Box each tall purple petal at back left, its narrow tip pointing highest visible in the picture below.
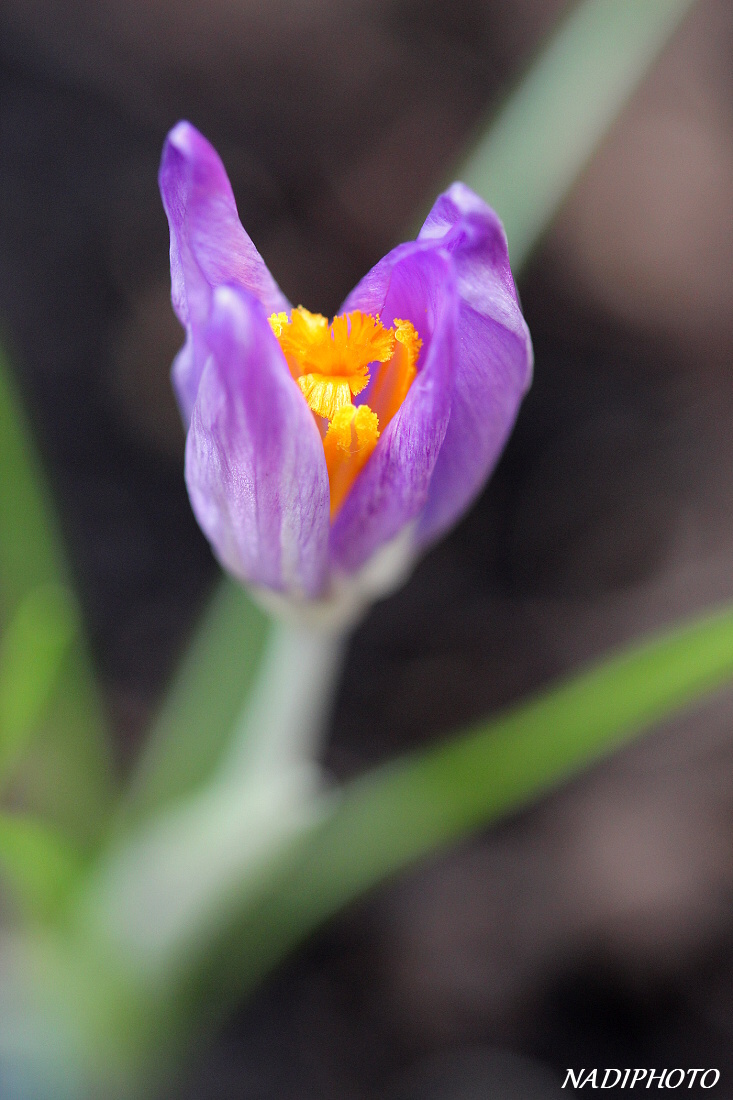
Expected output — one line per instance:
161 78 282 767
158 122 291 422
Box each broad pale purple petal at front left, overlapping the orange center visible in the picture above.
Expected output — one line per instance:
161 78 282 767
186 287 329 596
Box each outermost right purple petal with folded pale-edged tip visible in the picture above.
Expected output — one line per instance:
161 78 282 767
417 184 533 543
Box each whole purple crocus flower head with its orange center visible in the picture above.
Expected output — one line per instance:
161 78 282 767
160 122 532 620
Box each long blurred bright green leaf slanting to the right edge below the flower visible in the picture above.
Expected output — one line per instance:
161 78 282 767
197 607 733 997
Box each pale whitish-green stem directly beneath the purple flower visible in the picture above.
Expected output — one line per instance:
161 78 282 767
80 624 344 986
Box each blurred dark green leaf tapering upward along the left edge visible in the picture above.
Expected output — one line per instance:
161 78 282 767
0 338 111 842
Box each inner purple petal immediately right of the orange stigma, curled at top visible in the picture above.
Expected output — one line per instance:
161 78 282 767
330 245 457 572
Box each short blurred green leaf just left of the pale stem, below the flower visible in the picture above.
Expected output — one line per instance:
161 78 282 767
121 580 269 824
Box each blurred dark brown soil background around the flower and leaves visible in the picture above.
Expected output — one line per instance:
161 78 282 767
0 0 733 1100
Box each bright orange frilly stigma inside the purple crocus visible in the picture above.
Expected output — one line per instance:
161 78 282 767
270 306 423 519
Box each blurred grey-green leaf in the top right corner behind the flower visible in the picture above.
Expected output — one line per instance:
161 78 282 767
457 0 693 272
